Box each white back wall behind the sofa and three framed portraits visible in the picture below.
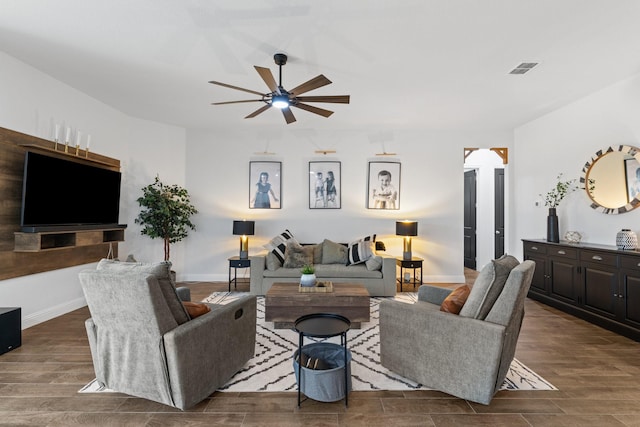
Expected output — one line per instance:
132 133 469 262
185 129 511 282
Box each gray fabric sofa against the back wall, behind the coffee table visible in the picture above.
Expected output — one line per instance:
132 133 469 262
249 240 396 296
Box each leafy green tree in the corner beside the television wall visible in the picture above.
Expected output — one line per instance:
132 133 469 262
135 176 198 261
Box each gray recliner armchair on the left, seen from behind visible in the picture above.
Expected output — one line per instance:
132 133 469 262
80 261 256 409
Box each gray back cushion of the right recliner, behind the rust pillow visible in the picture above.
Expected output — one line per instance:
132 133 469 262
460 254 520 320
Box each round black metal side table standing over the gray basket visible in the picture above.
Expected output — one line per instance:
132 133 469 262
294 313 351 408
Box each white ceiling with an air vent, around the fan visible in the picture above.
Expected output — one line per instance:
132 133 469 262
0 0 640 130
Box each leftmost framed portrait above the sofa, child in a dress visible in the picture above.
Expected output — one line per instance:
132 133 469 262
249 162 282 209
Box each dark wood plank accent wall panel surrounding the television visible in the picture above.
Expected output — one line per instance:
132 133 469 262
0 128 120 280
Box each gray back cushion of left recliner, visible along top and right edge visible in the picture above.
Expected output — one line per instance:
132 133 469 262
96 259 189 325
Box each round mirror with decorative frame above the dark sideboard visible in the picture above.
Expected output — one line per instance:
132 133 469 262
580 145 640 214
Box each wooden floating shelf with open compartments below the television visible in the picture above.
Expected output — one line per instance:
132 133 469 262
14 228 124 252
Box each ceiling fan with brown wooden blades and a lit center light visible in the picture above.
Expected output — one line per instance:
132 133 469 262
209 53 349 124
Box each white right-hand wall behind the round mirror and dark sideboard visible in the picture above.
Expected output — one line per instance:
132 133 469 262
510 75 640 256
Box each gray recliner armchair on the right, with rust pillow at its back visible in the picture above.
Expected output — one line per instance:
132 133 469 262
380 256 535 405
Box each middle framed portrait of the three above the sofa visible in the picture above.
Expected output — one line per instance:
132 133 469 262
309 162 342 209
